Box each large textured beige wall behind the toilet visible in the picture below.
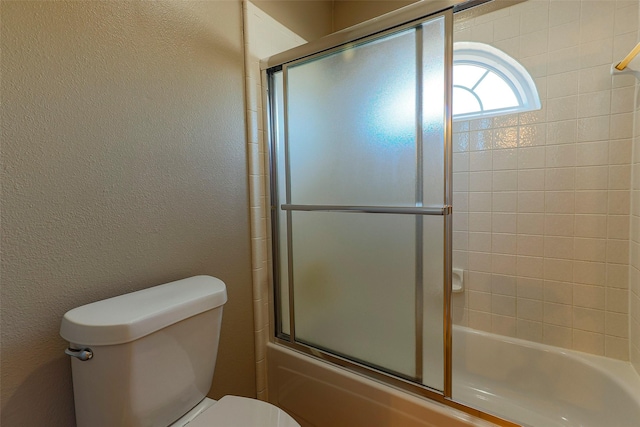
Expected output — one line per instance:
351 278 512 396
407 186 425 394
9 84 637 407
1 1 255 427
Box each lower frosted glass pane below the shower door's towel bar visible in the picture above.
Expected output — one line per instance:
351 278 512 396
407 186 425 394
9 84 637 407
292 212 416 377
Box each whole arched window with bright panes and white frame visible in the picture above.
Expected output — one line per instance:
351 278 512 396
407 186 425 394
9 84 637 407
453 42 540 120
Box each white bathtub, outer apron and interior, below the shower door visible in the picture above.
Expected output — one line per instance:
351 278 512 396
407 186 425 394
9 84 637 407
267 326 640 427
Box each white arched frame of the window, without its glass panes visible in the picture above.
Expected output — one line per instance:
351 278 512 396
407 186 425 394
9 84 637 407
453 42 541 120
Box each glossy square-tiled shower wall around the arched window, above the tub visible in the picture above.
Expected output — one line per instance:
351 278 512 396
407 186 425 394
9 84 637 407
453 0 640 362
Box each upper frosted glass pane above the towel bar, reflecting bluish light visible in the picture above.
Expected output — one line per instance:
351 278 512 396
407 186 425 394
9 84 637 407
287 29 416 206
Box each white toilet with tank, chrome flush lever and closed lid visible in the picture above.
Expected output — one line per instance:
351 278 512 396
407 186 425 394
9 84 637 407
60 276 300 427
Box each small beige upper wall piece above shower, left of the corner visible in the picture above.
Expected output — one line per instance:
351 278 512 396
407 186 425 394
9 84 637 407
252 0 333 41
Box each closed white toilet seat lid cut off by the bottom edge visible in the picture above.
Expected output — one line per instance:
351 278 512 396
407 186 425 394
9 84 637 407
188 396 300 427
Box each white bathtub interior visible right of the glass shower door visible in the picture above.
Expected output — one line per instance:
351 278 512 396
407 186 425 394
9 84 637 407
453 326 640 427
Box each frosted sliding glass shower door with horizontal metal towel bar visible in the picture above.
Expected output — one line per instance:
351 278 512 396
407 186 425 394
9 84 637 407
268 12 451 391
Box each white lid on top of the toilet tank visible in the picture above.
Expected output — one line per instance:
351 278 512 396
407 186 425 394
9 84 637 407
60 276 227 346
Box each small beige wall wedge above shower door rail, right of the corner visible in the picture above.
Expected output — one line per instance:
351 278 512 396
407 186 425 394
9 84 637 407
333 0 416 31
